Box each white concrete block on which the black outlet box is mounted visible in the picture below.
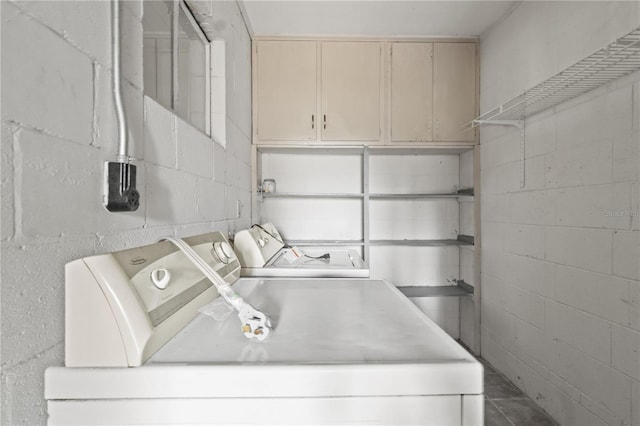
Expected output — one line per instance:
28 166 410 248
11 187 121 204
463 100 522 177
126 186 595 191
16 130 145 237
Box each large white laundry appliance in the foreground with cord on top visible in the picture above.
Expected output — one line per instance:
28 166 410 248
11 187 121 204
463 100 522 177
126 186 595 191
45 233 484 425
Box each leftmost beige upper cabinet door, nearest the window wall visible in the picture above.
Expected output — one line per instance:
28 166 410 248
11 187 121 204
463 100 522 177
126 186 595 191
255 41 318 141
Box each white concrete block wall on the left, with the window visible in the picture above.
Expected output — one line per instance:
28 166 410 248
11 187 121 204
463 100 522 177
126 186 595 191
0 1 251 425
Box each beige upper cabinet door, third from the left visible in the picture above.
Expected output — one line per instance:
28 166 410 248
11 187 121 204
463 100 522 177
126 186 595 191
390 43 433 142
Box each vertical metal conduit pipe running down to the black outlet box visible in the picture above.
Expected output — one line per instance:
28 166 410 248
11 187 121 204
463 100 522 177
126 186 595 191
111 0 129 163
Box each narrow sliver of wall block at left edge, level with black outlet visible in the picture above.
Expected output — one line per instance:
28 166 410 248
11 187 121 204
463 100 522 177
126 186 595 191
0 125 18 241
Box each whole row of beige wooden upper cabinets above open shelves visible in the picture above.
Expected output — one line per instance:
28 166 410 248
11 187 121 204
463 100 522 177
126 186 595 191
253 40 478 144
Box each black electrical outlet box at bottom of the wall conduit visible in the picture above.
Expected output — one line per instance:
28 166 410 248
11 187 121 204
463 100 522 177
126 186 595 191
103 161 140 212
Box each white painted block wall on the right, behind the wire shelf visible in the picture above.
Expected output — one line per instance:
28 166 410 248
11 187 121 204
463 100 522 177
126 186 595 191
480 2 640 425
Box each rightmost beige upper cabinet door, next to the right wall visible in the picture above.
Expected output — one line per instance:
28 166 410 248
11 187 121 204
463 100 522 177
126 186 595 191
433 43 476 141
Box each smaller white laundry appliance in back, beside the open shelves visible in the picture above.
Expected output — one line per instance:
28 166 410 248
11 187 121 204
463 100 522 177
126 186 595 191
234 223 369 278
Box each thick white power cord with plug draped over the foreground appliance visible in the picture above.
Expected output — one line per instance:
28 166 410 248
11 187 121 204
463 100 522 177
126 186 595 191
161 237 271 341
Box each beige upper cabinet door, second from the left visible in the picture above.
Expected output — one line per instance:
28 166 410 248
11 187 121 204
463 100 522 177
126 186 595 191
321 42 382 141
